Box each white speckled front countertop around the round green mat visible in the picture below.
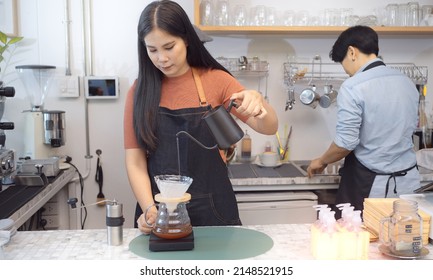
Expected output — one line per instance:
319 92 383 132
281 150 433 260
0 224 433 260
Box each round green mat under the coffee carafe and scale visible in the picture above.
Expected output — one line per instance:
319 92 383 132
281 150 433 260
129 227 274 260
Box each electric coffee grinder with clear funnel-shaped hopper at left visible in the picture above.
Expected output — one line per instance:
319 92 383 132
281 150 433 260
15 65 66 159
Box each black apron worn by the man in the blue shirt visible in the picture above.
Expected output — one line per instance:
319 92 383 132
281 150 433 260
336 61 417 213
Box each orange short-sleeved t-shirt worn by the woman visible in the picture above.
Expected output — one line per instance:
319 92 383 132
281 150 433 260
123 69 246 149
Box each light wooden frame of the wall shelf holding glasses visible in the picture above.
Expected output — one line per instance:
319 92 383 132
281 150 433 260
194 0 433 37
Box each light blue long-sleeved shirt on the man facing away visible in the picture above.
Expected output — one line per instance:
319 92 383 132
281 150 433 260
334 59 419 173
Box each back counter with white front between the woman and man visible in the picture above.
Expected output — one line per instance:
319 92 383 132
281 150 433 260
228 161 339 225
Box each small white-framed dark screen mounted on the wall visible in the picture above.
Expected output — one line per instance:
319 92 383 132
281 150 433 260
84 76 119 99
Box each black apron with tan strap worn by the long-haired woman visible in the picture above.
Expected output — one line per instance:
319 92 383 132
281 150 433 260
135 68 241 227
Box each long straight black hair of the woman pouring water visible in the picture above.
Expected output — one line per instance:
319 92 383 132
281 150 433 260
133 0 230 152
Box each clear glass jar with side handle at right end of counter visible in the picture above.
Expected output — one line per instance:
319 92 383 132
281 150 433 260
380 199 423 257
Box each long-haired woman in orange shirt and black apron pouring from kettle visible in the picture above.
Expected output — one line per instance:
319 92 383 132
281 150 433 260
124 0 278 233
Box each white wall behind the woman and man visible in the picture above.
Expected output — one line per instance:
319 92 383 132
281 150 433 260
2 0 433 228
